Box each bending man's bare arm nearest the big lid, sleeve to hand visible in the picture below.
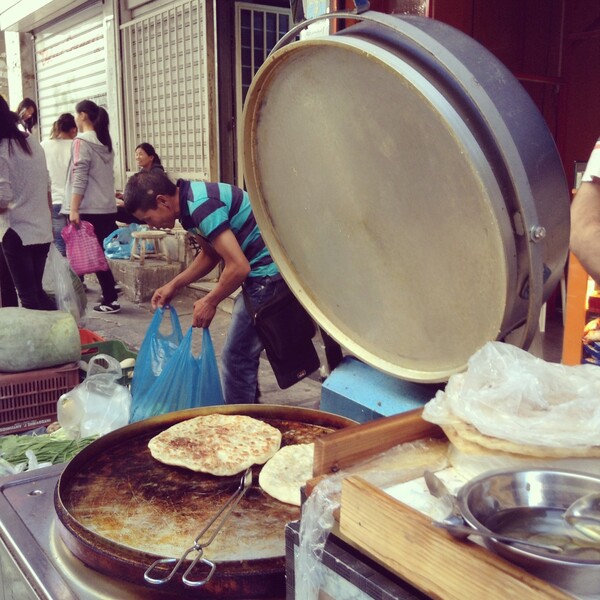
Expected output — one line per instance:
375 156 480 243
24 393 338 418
192 229 250 328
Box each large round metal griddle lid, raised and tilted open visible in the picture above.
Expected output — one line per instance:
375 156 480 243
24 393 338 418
244 12 569 382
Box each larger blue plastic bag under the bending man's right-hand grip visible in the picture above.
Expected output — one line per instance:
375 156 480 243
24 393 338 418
130 327 224 423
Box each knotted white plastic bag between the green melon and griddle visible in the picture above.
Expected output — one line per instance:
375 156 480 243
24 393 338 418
57 354 131 439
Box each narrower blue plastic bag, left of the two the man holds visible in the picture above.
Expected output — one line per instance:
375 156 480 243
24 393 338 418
131 305 183 398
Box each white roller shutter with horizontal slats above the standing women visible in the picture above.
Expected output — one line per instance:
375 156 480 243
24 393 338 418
34 2 107 139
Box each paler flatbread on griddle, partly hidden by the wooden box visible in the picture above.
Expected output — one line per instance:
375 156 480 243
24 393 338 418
258 444 315 506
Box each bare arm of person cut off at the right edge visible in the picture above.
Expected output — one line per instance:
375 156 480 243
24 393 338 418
570 179 600 283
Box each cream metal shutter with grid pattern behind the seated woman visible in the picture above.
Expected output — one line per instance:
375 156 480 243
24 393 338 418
121 0 216 179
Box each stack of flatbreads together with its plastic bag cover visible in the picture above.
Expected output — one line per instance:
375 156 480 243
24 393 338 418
423 342 600 476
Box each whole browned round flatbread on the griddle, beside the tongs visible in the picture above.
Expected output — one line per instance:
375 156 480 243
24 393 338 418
148 414 281 476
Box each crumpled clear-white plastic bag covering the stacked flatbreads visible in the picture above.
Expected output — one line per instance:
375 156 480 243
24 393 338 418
423 342 600 448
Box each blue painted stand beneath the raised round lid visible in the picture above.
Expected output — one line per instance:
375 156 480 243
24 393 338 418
320 356 446 423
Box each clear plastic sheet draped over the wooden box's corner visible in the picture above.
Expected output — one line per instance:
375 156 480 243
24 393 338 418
296 440 447 600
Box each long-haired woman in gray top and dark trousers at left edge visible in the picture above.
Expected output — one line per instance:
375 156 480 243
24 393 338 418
0 96 56 310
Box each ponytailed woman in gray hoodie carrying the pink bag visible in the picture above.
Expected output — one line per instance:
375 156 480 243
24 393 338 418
61 100 121 313
